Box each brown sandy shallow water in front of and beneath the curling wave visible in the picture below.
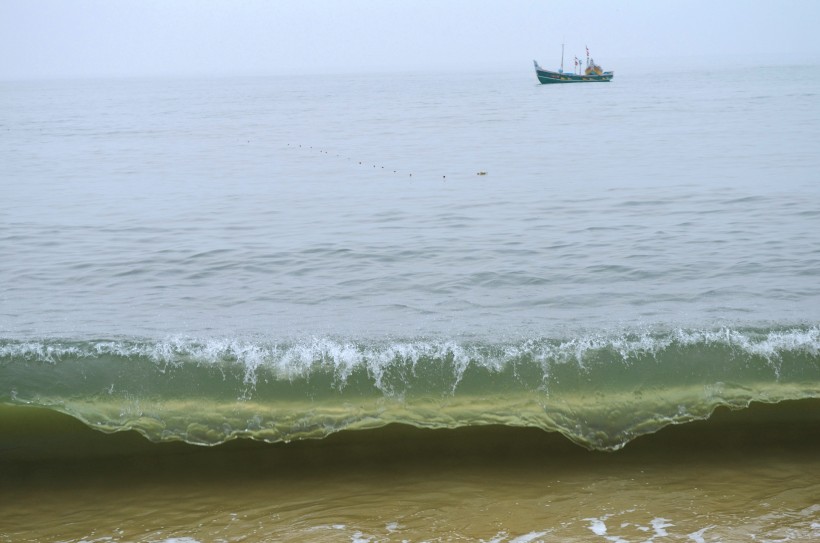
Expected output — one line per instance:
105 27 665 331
0 401 820 543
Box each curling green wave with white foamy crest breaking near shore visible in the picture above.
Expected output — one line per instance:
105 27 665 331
0 326 820 450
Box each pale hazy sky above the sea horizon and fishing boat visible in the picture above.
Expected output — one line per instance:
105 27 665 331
0 0 820 79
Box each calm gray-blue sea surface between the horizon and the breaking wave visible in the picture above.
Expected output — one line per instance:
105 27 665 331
0 68 820 338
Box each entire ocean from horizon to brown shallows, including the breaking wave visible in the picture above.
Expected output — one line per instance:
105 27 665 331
0 68 820 543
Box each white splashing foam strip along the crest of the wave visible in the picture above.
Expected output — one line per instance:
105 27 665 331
0 326 820 377
